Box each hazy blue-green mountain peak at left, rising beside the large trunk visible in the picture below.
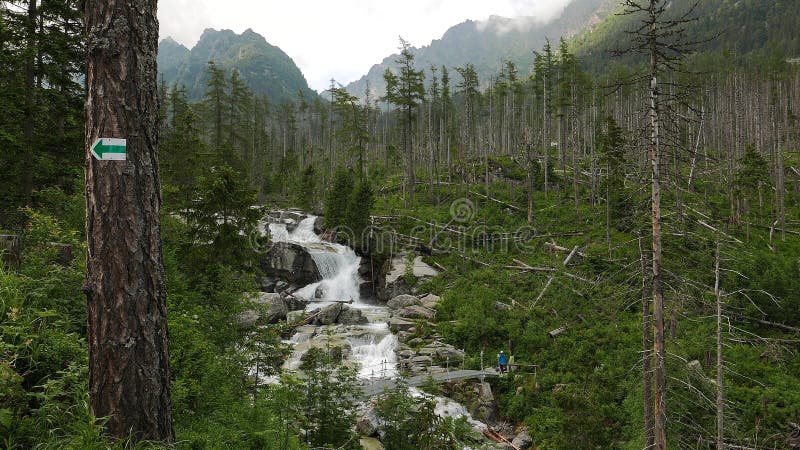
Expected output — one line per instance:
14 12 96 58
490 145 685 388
158 28 317 102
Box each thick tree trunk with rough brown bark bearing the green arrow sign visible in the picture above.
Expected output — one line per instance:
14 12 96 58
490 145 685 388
84 0 174 442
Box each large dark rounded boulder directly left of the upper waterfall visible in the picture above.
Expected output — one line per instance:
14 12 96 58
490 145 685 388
261 242 322 285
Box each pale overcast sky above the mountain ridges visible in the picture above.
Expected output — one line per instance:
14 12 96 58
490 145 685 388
158 0 579 91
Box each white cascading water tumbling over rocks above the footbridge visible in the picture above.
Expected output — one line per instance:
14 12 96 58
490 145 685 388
269 216 397 379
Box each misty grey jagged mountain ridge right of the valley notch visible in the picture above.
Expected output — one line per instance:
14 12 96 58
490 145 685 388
346 0 617 98
